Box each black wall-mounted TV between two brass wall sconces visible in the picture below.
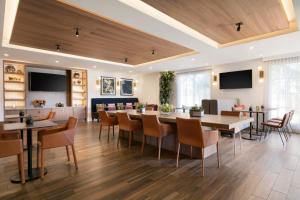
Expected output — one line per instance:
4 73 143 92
219 70 252 89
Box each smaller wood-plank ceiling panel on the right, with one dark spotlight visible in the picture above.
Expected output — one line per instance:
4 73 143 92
142 0 289 44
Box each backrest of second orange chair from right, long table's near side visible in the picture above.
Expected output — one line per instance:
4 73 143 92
142 114 160 137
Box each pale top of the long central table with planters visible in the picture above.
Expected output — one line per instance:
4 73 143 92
108 110 254 129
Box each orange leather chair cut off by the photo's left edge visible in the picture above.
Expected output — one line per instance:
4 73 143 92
0 130 25 184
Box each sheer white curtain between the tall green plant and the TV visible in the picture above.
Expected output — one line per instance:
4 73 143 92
176 71 211 107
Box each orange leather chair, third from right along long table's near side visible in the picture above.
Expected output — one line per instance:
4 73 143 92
117 112 142 149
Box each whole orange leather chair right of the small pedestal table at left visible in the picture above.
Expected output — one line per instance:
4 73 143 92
38 117 78 177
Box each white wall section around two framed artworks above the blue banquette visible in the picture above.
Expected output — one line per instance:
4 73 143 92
88 69 141 119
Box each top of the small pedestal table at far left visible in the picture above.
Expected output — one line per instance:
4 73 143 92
3 120 58 131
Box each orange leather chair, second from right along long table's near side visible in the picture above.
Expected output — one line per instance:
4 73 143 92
142 115 176 160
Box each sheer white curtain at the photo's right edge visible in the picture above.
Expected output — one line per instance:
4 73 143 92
265 57 300 132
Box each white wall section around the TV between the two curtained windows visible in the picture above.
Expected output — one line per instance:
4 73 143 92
211 60 267 107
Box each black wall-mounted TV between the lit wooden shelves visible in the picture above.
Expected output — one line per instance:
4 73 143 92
28 72 67 92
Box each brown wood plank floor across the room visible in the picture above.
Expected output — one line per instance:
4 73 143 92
0 123 300 200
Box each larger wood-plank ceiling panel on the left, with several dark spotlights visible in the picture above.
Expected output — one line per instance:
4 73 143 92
10 0 192 65
